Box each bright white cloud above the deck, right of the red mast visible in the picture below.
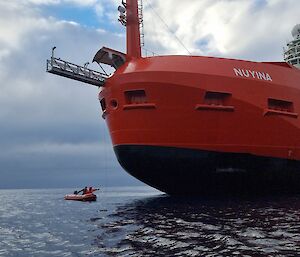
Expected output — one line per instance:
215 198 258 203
144 0 300 61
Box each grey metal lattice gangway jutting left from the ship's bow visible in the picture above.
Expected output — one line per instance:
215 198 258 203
47 48 109 87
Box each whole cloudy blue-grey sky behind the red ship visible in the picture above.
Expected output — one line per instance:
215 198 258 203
0 0 300 189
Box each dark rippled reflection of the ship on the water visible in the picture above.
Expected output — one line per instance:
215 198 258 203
93 196 300 256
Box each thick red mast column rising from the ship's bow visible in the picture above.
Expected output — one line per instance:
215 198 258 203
126 0 142 59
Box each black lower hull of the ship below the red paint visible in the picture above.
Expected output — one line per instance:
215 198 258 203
114 145 300 195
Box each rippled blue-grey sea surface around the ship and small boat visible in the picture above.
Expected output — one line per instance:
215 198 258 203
0 187 300 257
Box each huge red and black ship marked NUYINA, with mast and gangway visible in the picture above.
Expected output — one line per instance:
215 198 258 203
48 0 300 195
